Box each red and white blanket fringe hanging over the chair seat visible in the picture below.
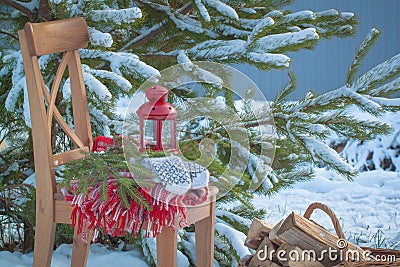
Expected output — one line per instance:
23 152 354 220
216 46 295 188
61 179 208 242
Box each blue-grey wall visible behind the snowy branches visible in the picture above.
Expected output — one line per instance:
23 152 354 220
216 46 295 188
234 0 400 100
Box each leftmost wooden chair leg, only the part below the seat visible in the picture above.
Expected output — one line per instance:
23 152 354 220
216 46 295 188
33 219 56 267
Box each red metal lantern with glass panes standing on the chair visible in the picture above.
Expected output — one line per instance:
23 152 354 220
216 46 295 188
136 85 178 152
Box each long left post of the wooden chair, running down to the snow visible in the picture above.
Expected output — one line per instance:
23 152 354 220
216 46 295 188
18 31 56 267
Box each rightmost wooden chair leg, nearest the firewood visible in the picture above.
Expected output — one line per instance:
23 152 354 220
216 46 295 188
195 200 215 267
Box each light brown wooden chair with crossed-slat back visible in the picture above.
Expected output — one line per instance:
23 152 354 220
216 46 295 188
18 18 218 267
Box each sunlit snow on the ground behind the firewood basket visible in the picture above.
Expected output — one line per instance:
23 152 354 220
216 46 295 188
254 169 400 249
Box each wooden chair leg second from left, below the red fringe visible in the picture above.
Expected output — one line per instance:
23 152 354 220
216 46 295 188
71 225 93 267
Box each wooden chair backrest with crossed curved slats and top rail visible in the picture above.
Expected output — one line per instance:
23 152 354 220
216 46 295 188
18 18 92 197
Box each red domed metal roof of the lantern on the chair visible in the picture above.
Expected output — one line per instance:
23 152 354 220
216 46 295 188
136 85 178 120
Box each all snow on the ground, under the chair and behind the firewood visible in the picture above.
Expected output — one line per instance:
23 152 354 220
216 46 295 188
0 169 400 267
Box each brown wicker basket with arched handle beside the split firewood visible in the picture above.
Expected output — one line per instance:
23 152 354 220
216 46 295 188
304 202 400 267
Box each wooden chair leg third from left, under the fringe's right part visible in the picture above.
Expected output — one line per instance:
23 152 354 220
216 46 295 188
156 227 178 267
